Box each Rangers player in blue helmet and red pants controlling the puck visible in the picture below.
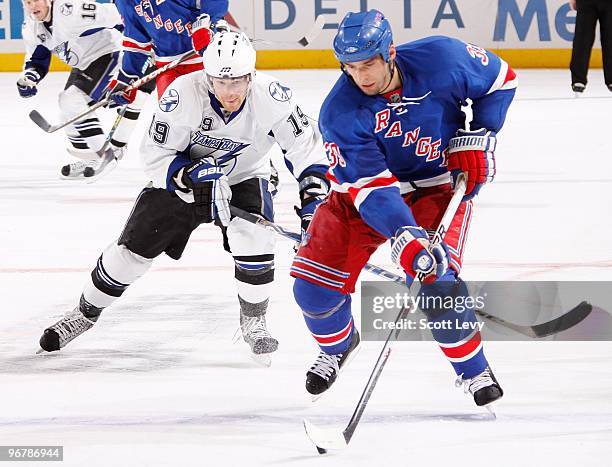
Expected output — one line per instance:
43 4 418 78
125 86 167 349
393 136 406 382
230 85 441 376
291 10 517 406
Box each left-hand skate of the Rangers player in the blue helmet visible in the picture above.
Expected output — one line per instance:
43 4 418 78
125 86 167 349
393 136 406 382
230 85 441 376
306 329 361 402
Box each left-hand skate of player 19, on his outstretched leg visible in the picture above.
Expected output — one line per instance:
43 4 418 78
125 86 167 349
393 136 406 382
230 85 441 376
37 297 102 353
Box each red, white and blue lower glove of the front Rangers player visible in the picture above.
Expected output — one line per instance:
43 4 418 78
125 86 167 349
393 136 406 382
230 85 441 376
391 226 450 284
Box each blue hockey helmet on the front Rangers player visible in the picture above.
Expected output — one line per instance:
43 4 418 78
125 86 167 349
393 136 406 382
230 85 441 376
334 9 393 63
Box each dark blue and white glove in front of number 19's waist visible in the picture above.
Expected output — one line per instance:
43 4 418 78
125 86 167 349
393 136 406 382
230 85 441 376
173 158 232 227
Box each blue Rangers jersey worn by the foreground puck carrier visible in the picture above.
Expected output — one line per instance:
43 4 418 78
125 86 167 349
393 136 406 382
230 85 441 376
319 36 517 238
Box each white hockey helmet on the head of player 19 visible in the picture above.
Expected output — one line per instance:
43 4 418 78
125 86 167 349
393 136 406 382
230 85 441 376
203 31 257 78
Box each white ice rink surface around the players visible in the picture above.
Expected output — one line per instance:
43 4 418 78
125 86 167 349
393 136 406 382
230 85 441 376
0 70 612 467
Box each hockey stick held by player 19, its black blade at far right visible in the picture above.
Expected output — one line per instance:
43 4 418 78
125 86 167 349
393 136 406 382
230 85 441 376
230 206 593 337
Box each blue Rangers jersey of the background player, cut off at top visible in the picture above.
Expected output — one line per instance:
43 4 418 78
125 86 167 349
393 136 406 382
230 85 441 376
115 0 228 78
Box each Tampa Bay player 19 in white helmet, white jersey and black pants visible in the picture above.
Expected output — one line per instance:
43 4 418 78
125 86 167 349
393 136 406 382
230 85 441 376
40 32 329 364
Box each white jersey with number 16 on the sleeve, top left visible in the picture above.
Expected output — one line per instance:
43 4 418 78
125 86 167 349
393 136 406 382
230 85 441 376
22 0 122 70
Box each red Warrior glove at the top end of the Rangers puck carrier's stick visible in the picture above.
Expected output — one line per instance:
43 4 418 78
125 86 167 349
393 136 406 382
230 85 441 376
448 128 496 201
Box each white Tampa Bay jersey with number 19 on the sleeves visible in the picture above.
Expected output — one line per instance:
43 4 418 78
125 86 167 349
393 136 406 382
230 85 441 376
141 71 328 188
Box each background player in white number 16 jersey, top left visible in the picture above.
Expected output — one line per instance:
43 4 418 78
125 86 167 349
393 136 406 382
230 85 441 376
17 0 154 179
